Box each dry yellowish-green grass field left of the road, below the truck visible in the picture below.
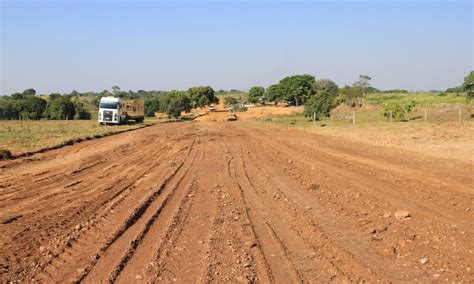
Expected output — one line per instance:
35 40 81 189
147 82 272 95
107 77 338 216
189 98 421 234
0 118 160 155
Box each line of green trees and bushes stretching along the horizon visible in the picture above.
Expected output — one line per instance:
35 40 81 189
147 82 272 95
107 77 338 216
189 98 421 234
0 71 474 120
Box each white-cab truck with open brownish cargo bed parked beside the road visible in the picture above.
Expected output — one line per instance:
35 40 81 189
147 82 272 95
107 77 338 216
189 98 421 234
98 97 145 124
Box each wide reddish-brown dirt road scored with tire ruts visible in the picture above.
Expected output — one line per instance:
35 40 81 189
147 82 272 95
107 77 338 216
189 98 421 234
0 121 474 283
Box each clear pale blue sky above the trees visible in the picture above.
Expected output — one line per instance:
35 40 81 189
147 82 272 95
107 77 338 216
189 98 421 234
0 0 474 95
